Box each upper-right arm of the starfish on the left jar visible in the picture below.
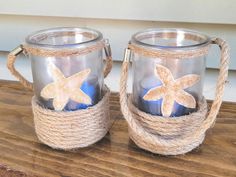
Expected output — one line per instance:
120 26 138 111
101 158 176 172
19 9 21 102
66 69 91 90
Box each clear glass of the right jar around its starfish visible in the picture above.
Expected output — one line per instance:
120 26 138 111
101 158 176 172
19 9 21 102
131 29 210 117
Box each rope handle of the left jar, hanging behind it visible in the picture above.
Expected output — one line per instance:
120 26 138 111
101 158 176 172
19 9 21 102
7 40 112 90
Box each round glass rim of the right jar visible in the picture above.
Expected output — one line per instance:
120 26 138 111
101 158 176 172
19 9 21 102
130 28 211 50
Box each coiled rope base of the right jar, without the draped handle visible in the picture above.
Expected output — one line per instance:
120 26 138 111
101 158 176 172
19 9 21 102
128 98 208 155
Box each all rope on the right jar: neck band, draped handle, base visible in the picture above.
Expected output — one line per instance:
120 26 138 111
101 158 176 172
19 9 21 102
120 38 229 155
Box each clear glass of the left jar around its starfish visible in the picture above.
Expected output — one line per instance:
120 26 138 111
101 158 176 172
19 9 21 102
26 28 103 111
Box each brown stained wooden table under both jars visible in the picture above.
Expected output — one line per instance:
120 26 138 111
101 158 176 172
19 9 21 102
0 81 236 177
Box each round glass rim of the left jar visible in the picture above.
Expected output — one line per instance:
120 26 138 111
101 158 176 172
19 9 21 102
25 27 103 48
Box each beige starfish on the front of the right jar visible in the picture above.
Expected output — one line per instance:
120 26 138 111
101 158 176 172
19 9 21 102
143 65 200 117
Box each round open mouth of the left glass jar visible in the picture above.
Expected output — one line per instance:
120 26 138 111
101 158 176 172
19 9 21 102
26 27 102 48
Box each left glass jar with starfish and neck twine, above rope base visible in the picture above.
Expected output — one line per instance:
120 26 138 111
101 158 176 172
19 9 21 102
10 27 109 111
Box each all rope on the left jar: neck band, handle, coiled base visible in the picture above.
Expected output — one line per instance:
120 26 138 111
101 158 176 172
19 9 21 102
7 38 112 150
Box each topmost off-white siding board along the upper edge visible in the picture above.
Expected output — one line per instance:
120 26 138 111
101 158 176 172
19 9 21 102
0 0 236 24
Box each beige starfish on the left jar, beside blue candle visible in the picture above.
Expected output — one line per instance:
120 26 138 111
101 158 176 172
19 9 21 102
40 64 92 111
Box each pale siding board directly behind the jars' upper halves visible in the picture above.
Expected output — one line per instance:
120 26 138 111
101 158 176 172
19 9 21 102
0 15 236 69
